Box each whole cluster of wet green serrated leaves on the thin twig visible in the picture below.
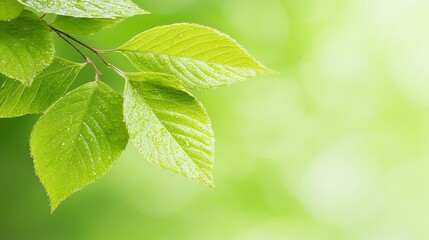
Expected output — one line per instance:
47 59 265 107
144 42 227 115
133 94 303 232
0 0 273 211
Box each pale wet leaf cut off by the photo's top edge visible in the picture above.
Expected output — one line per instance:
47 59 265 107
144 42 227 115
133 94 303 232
19 0 149 18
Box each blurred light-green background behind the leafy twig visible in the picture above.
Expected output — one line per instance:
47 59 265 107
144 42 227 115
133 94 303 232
0 0 429 240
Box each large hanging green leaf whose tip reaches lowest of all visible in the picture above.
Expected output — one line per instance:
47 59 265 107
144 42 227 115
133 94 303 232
30 81 128 211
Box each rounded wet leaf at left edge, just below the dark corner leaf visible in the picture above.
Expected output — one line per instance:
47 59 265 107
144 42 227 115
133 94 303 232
0 11 55 86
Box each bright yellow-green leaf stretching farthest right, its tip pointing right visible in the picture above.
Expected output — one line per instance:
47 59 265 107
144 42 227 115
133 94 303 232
116 23 273 90
